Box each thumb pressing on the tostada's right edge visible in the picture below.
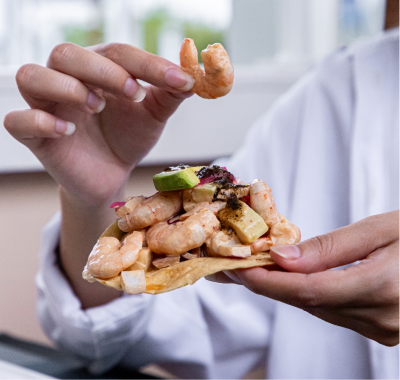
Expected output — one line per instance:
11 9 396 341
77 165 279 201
271 211 400 273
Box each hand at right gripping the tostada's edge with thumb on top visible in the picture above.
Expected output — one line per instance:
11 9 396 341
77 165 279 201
227 211 400 346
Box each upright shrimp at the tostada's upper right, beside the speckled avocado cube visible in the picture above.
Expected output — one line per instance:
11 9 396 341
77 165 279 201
250 179 280 227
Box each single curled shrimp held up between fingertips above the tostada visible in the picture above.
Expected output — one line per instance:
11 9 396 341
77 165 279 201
180 38 233 99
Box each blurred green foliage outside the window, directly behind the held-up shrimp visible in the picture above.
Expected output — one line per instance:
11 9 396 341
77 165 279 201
143 9 225 63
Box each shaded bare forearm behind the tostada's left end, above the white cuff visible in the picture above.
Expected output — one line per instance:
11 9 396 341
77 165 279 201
60 188 124 309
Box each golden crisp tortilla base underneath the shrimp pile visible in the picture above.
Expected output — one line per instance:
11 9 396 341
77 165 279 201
90 221 275 294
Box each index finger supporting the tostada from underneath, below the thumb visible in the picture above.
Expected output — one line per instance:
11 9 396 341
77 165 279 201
235 254 386 308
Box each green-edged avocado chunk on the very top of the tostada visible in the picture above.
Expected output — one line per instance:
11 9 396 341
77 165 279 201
153 168 200 191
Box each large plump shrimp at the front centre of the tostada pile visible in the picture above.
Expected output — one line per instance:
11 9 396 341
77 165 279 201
147 209 221 256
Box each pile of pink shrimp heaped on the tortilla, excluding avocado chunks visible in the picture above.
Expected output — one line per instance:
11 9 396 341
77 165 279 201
87 168 300 279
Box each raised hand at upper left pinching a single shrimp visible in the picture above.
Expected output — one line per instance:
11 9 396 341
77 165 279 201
4 43 193 206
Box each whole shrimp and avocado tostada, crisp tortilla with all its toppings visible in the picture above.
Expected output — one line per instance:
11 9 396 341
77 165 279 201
82 165 301 294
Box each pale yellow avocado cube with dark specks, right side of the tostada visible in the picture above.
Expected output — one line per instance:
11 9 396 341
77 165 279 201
218 200 268 244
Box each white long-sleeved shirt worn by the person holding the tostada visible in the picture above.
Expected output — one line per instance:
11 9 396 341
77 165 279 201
37 29 400 380
